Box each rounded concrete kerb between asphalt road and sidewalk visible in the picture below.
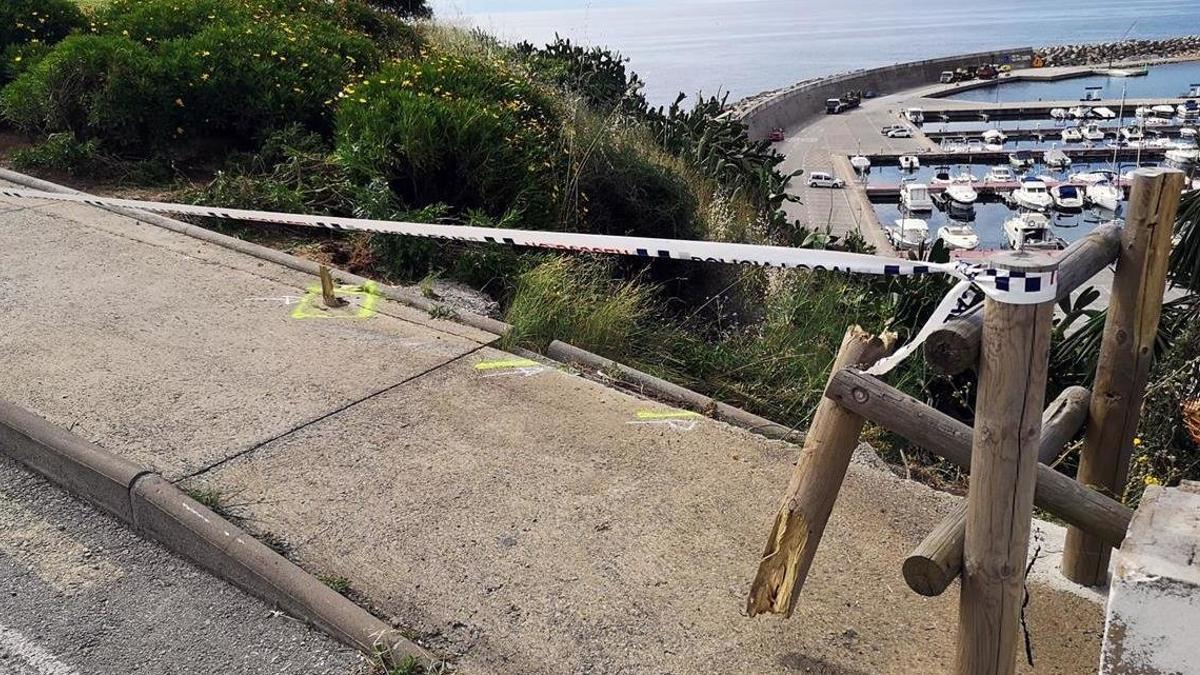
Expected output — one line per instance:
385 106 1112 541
0 400 436 665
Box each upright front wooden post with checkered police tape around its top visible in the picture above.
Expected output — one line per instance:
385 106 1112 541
955 252 1055 675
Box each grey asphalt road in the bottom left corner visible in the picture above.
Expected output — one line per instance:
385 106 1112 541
0 459 368 675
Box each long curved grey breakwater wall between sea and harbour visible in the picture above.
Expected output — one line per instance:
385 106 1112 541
733 47 1033 139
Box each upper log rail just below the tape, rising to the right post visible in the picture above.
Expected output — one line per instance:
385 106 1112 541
922 222 1122 375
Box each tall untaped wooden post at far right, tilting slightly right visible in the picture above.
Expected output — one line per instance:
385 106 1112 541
1062 168 1184 586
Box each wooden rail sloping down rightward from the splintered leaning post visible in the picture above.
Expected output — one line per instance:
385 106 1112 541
826 369 1133 545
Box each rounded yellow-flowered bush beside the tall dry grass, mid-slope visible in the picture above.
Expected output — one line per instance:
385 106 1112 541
337 55 557 226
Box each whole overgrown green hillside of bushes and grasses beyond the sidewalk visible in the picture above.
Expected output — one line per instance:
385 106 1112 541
0 0 1195 494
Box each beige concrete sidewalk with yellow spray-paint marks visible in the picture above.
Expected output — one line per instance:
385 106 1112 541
0 182 1102 675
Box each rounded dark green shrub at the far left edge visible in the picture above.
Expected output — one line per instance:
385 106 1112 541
0 35 152 141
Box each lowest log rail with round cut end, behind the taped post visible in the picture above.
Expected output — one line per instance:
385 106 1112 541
902 387 1091 596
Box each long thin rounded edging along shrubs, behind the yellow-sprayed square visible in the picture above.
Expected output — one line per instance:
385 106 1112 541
0 168 512 336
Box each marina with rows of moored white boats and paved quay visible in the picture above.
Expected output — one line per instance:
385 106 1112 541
780 56 1200 252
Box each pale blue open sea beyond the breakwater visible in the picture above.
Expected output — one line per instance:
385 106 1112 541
432 0 1200 104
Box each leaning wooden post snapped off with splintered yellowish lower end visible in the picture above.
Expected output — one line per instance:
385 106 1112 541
746 325 896 616
